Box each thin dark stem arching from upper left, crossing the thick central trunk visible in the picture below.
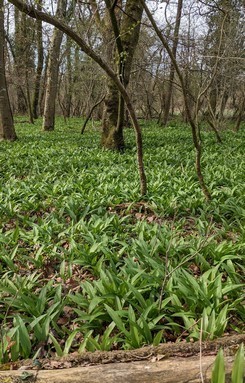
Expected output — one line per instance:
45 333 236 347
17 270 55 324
9 0 147 196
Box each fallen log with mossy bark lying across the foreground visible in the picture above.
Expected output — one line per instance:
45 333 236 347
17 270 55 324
0 334 245 383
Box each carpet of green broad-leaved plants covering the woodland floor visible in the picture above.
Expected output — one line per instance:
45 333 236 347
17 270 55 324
0 119 245 363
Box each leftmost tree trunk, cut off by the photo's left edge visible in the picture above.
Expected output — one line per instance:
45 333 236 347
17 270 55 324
0 0 17 141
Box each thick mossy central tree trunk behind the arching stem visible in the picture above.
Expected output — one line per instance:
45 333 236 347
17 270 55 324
101 0 143 150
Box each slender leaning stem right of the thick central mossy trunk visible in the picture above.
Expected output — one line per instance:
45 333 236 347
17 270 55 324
140 0 211 201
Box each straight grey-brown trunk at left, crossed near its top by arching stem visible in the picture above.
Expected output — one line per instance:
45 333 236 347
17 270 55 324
43 0 66 131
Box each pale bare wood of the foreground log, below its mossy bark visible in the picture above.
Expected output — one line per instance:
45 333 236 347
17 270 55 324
0 355 242 383
